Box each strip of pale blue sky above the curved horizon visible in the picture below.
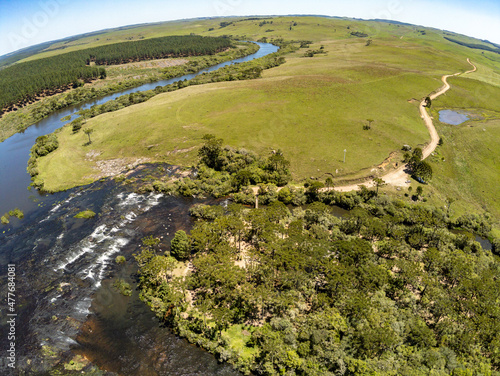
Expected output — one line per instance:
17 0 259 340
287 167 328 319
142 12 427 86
0 0 500 55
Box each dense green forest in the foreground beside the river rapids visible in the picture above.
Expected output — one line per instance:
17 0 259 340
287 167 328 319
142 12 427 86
135 136 500 376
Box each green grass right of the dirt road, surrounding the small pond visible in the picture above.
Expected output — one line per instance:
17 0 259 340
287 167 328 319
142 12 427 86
420 69 500 221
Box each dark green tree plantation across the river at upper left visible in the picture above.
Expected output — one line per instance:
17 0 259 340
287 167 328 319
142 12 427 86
0 35 232 115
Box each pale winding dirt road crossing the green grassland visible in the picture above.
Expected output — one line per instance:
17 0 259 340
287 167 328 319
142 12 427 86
332 59 477 192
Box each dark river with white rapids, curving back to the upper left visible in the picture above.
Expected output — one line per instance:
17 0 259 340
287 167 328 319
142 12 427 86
0 43 278 375
